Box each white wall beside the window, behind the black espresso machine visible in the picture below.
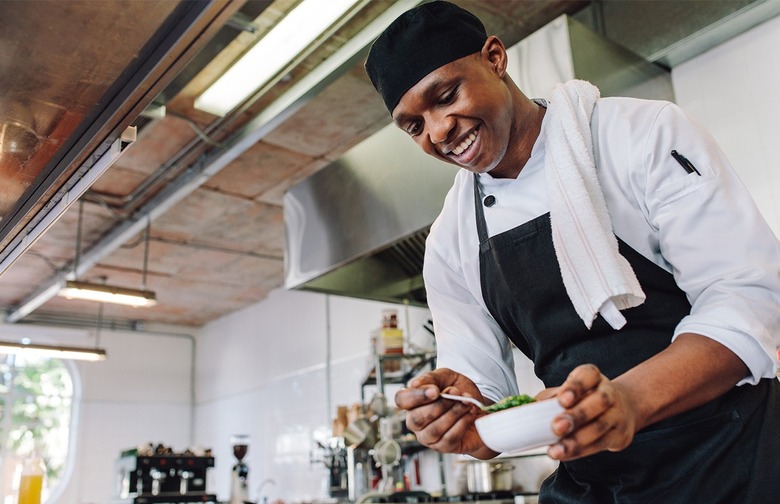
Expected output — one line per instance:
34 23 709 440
0 325 193 504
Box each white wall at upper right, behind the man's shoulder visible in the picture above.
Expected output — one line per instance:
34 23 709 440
672 13 780 236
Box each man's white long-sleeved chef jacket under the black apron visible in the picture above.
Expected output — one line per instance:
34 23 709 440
424 98 780 400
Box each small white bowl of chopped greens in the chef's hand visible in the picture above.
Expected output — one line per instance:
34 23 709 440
476 398 563 453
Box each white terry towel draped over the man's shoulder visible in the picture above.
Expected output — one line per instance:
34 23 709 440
545 80 645 329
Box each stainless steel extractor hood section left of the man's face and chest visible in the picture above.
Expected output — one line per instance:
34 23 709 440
284 124 457 305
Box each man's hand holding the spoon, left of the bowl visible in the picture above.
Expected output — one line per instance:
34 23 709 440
395 368 497 459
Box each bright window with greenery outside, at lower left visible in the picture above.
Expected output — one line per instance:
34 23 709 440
0 354 73 504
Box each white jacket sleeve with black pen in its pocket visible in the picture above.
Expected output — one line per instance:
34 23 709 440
642 103 780 384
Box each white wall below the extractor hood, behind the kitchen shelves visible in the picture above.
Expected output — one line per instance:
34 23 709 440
190 290 428 501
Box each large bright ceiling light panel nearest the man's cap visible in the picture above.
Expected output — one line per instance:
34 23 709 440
194 0 359 116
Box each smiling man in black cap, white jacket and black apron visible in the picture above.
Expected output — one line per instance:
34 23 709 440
366 2 780 504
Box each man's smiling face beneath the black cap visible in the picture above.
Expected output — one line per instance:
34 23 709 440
393 45 516 177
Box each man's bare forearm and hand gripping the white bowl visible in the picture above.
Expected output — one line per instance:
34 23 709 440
537 333 748 460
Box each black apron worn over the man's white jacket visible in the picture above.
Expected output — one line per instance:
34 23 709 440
474 175 780 504
